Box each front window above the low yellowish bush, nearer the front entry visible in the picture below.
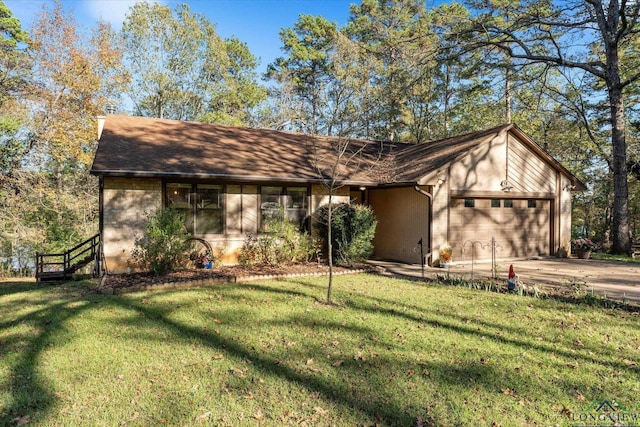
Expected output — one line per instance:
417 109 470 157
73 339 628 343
260 187 308 231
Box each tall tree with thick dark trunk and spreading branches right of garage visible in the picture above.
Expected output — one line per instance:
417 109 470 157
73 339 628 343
469 0 640 254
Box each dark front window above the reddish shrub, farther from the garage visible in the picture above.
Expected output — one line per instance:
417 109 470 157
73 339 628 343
167 183 224 235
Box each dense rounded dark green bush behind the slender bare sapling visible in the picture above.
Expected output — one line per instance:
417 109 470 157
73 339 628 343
315 203 378 264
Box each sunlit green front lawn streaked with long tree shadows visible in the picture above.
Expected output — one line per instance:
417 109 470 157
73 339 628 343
0 274 640 426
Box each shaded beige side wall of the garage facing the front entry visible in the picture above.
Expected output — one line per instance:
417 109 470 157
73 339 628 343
369 187 429 263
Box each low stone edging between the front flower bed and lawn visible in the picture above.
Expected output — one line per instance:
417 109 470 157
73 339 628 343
96 268 375 295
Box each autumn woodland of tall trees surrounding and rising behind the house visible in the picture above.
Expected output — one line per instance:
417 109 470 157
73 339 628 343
0 0 640 275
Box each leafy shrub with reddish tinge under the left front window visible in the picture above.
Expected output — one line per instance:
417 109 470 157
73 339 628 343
132 208 192 276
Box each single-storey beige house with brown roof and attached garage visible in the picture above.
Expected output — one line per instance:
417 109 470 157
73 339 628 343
91 115 584 272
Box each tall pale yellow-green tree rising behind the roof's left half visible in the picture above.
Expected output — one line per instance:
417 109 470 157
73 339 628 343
122 2 266 124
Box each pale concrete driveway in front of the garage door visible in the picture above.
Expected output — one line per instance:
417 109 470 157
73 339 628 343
371 258 640 304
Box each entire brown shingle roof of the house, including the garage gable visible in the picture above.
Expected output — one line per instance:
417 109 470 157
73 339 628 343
91 115 583 190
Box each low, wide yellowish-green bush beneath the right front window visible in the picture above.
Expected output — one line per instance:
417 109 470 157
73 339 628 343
238 218 315 267
